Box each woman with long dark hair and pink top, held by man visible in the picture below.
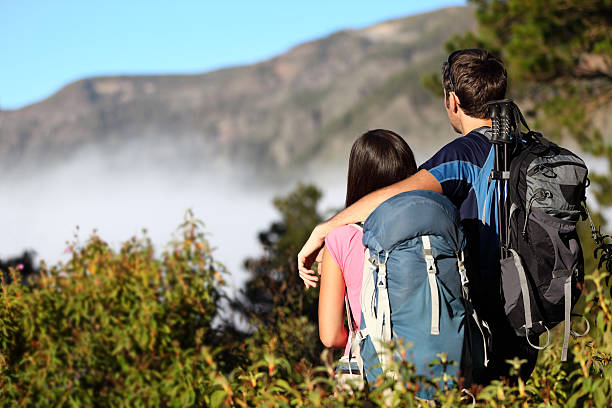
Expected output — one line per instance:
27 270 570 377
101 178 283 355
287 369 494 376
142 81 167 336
319 129 416 356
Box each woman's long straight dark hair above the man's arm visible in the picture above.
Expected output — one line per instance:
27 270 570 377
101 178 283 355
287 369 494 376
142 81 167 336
346 129 416 207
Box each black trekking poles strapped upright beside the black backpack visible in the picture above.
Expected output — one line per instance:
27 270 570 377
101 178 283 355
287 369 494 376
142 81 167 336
487 99 514 259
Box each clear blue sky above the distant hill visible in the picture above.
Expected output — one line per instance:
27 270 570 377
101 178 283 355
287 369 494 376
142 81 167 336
0 0 466 109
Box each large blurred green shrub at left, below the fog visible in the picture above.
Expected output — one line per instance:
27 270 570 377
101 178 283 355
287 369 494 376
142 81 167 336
0 213 223 406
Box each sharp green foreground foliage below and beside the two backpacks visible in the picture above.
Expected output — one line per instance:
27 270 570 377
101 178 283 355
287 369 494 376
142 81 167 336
186 273 612 407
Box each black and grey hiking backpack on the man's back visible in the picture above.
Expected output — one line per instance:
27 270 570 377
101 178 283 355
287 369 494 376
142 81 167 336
501 131 589 361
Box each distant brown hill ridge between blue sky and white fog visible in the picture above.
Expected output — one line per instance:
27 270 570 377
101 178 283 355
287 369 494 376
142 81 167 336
0 7 475 178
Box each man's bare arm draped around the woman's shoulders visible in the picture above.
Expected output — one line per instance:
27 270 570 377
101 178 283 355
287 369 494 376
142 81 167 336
298 170 442 288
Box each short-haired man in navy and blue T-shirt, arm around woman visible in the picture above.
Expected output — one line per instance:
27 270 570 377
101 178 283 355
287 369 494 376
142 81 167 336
298 49 537 380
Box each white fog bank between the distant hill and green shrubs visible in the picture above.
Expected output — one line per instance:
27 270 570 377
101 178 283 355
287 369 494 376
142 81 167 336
0 154 345 296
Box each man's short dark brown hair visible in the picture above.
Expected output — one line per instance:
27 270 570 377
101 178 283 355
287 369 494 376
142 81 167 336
442 48 508 119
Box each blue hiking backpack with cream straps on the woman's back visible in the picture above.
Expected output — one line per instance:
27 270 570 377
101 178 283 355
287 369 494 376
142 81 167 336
347 191 490 399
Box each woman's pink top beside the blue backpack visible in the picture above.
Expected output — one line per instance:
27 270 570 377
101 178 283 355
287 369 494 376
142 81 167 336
325 225 365 354
